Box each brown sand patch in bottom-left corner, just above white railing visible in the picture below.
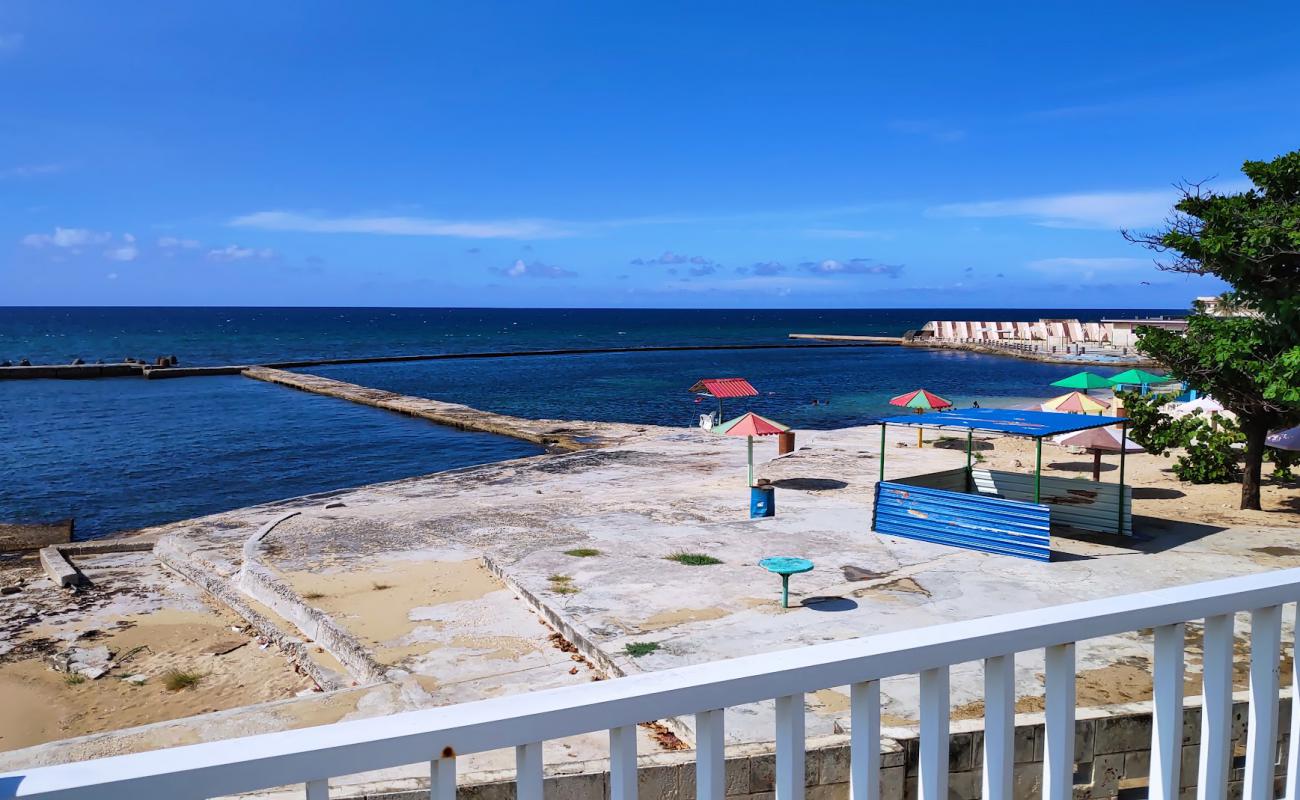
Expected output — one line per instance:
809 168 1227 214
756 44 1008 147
0 609 311 751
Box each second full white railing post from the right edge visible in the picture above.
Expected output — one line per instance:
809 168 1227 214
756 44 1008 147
1196 614 1232 800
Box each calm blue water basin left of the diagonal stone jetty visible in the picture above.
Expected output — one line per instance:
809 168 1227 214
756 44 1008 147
0 376 541 539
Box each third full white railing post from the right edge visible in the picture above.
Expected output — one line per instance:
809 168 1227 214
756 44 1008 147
1149 622 1186 800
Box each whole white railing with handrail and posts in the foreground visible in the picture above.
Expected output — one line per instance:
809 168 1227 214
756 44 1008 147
0 570 1300 800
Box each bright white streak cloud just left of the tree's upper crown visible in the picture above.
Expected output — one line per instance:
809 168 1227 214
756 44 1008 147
930 189 1178 229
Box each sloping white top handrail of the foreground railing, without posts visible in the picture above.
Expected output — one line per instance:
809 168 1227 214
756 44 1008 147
0 568 1300 800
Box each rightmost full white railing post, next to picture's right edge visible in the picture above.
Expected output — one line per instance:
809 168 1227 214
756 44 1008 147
1244 606 1282 800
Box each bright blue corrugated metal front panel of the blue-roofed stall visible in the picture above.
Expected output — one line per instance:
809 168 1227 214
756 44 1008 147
871 481 1052 561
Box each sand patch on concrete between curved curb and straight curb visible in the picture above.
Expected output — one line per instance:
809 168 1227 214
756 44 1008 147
283 559 503 665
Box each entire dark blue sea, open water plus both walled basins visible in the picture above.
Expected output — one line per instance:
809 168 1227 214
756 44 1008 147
0 308 1170 539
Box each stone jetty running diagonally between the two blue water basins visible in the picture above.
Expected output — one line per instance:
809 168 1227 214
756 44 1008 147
243 367 634 453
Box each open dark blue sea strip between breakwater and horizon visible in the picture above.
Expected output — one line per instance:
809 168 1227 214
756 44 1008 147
0 307 1177 366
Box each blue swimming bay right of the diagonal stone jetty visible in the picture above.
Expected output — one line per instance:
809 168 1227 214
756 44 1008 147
309 347 1092 429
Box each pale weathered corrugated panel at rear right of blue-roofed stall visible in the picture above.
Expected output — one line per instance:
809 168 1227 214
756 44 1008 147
971 470 1134 536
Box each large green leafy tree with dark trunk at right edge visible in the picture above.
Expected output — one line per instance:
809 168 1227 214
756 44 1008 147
1125 151 1300 509
